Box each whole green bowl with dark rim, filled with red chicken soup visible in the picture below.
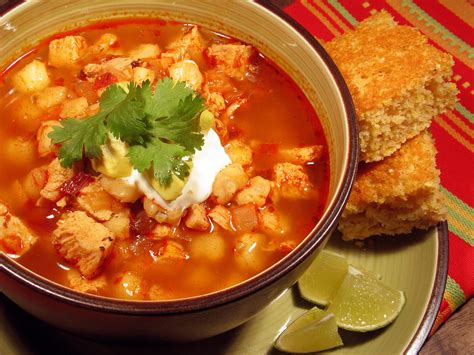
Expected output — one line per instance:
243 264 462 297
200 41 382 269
0 0 358 341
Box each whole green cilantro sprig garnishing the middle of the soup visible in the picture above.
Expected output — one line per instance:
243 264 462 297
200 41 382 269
48 78 204 186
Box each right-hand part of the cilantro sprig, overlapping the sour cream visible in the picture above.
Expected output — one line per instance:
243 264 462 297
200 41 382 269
129 78 204 186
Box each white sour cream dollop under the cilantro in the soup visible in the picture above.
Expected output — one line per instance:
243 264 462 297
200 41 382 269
124 129 231 210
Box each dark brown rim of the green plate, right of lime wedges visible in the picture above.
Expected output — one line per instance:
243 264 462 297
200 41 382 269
403 221 449 354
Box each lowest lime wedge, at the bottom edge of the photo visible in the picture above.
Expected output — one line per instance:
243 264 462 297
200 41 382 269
275 307 343 354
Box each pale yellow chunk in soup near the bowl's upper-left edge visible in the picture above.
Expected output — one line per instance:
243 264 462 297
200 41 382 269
12 59 50 92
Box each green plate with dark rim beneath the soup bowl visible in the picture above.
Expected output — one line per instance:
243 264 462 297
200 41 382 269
0 223 448 355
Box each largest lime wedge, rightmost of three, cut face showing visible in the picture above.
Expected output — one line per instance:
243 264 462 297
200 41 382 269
327 266 405 332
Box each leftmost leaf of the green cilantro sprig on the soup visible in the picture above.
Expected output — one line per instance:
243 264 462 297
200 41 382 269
48 113 107 168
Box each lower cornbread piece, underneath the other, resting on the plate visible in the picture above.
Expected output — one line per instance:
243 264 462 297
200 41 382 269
339 131 446 240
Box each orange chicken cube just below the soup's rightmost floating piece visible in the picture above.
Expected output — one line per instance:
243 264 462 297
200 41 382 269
273 163 312 199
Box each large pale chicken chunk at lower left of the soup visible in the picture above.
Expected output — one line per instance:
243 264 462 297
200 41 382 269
53 211 115 279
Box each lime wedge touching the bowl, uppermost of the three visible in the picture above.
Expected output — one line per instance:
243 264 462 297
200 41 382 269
298 250 348 306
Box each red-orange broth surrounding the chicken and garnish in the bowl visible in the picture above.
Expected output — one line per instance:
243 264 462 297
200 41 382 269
0 19 329 300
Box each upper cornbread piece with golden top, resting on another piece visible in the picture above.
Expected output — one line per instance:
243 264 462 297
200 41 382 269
325 11 457 162
